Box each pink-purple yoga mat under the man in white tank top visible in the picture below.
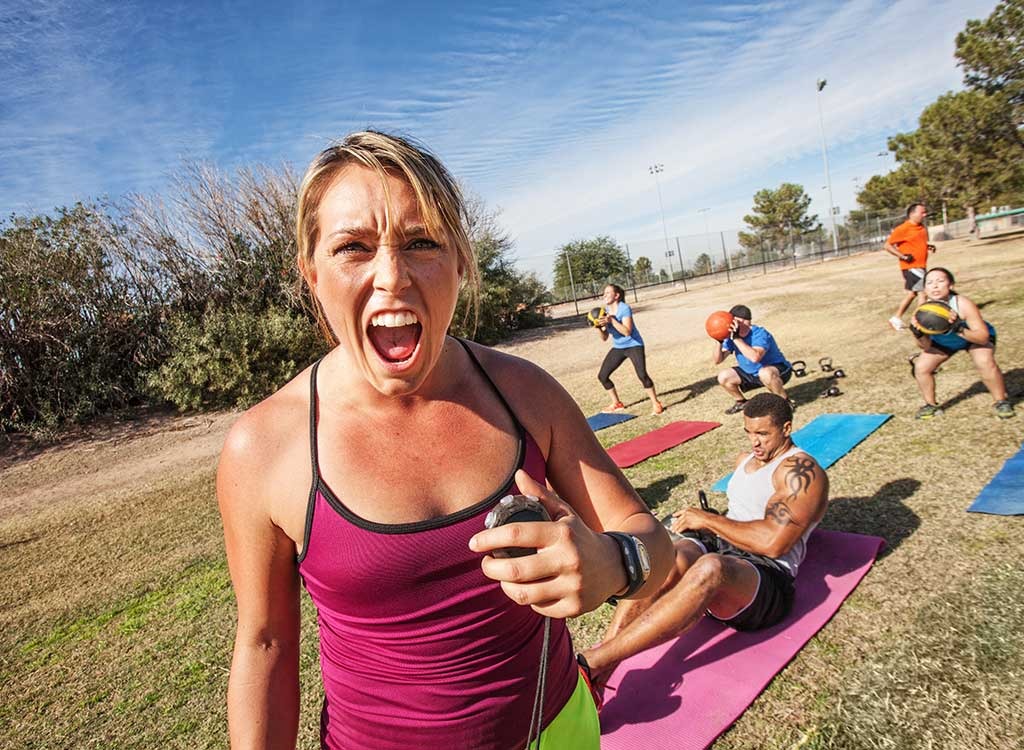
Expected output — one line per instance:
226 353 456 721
601 530 885 750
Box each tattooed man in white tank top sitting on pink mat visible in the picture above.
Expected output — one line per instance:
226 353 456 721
581 393 828 692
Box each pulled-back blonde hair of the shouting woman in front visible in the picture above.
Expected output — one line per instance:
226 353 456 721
295 130 480 345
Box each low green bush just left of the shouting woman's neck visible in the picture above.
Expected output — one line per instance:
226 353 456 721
148 306 327 410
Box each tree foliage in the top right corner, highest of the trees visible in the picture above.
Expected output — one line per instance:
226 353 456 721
955 0 1024 127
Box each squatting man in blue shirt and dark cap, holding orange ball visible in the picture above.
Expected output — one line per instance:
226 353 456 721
714 304 793 414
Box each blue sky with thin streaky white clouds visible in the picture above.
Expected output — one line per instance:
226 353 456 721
0 0 994 276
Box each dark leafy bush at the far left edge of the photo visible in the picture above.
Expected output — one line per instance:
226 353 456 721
0 204 160 431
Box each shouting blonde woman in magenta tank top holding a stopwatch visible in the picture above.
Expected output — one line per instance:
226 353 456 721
217 132 672 750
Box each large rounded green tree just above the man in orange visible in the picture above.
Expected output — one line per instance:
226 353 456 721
889 90 1024 221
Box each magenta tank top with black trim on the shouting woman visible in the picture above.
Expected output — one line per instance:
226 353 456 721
298 347 578 750
